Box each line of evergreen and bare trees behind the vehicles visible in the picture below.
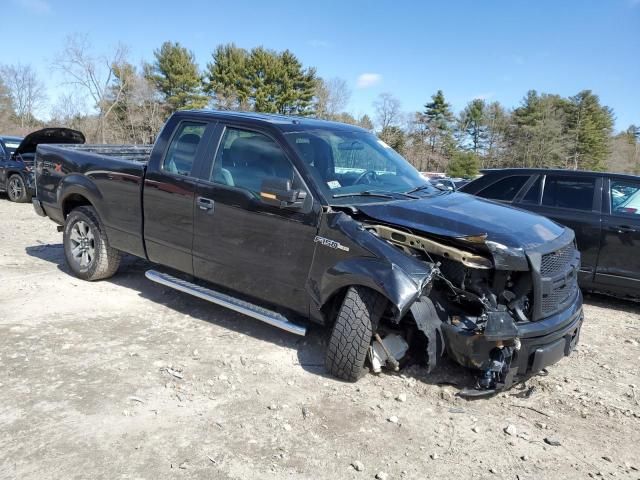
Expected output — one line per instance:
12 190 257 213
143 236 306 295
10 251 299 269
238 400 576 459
0 35 640 177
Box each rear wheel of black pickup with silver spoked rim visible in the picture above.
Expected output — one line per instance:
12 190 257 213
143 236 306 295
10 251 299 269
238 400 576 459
63 207 122 282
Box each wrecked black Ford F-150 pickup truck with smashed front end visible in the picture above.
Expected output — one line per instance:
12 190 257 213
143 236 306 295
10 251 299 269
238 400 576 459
33 111 583 394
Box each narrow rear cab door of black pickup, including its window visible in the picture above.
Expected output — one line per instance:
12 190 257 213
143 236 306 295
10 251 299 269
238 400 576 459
143 121 213 274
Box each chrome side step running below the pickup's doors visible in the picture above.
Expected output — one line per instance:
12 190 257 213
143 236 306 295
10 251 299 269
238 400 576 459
144 270 307 336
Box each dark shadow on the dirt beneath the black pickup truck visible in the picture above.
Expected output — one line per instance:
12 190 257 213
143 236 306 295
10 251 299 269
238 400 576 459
25 244 536 391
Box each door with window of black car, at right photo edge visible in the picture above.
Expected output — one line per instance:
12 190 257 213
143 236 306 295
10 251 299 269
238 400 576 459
596 179 640 286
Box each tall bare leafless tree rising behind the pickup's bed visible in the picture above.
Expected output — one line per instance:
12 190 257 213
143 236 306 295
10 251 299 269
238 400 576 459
54 34 128 143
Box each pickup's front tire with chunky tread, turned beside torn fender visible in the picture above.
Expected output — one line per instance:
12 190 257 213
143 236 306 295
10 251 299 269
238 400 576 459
325 287 387 382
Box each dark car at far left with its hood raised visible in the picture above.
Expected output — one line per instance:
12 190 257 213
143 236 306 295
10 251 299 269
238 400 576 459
0 128 85 203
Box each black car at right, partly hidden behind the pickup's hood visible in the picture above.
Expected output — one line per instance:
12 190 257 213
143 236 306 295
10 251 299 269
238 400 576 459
462 169 640 298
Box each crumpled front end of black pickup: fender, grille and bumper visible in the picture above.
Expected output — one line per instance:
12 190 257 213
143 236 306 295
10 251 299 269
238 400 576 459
308 204 582 390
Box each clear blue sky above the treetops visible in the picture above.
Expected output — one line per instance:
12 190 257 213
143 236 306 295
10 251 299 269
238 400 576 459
5 0 640 129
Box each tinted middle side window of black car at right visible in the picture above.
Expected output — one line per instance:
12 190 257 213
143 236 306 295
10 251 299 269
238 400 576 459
542 175 596 211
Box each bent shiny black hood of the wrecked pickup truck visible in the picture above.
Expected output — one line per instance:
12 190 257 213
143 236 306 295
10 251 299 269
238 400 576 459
358 192 565 250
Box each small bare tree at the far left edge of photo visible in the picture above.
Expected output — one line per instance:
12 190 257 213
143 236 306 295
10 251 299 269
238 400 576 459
0 64 47 128
